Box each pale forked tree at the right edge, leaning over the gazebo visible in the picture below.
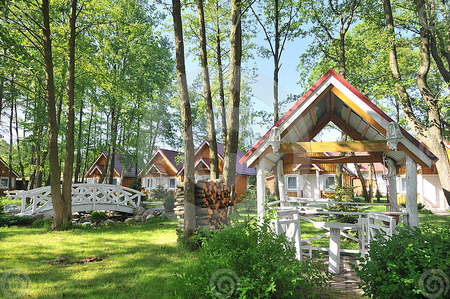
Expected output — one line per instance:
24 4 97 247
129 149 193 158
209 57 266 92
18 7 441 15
383 0 450 204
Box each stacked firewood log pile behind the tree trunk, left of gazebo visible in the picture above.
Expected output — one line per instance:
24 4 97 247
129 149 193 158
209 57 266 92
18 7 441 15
174 181 234 229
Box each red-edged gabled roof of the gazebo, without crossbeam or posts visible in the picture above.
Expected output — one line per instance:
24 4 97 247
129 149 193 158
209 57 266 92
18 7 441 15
240 69 438 169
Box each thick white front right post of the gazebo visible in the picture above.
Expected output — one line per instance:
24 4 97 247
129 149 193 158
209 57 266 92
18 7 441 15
406 156 419 227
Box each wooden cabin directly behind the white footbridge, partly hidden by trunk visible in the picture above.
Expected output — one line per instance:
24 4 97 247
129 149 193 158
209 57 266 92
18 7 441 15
85 151 139 187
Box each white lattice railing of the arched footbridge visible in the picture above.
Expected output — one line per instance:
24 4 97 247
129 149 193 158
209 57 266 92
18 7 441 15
14 184 143 215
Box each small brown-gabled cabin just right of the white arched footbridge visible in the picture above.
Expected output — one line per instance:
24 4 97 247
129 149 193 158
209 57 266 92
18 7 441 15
139 148 184 196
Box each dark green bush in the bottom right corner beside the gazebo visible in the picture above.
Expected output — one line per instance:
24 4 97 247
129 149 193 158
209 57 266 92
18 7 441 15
355 226 450 299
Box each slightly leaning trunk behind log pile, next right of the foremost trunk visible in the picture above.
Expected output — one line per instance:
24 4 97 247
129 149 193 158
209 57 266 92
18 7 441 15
197 0 219 179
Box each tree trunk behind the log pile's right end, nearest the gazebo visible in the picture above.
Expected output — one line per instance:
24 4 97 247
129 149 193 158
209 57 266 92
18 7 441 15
223 0 242 194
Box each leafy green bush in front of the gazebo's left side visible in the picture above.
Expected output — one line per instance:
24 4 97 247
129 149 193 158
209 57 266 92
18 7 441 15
175 220 327 298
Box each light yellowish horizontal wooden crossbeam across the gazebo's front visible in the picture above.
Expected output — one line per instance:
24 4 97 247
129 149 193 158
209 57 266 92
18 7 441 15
278 140 390 153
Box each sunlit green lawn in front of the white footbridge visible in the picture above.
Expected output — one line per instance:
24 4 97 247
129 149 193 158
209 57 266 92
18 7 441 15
0 218 195 298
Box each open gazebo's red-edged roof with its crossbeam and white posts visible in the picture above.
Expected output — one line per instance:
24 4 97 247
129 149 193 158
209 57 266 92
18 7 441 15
240 69 438 227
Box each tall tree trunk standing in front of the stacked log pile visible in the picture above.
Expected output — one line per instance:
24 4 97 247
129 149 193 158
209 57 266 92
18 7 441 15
172 0 197 241
